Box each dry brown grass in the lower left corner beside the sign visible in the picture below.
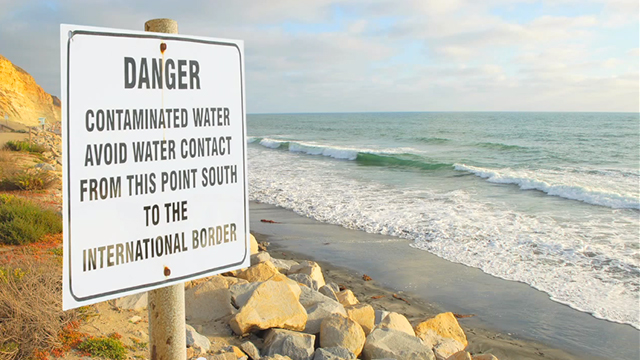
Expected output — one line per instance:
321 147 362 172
0 236 78 360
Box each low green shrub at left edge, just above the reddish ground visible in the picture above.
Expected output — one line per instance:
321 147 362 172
0 195 62 245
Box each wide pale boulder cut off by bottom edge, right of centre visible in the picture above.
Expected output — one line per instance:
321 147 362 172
362 328 435 360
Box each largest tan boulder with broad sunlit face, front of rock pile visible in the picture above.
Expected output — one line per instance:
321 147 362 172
229 280 307 335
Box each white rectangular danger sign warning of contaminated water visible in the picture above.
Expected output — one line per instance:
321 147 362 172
60 25 249 309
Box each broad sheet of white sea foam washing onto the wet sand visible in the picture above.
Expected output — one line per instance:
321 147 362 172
249 148 640 329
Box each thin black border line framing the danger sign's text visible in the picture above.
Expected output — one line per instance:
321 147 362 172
66 30 249 302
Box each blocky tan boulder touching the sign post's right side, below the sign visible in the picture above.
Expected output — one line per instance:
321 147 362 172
184 276 235 322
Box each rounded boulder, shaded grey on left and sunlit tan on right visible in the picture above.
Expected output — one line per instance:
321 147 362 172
320 314 366 356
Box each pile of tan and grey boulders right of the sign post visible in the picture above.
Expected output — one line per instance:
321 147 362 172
170 236 497 360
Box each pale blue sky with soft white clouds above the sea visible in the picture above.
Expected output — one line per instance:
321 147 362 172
0 0 640 113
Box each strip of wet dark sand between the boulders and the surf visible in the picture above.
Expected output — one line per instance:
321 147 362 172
250 202 638 359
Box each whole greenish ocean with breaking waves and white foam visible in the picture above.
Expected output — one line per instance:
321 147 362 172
247 112 640 329
